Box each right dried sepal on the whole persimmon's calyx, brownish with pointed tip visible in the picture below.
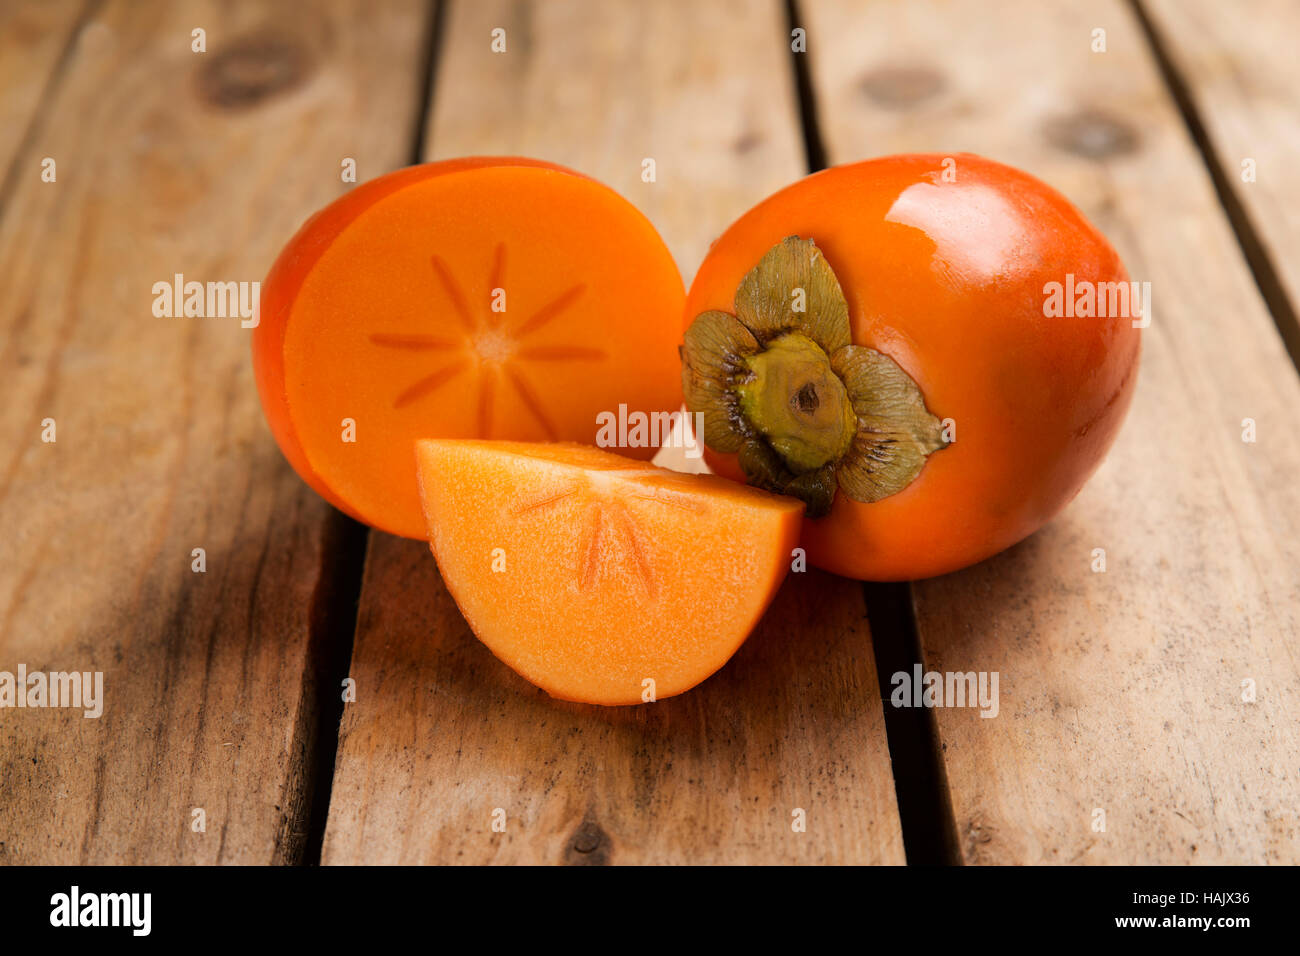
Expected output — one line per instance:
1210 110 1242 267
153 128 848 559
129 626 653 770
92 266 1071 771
831 345 946 502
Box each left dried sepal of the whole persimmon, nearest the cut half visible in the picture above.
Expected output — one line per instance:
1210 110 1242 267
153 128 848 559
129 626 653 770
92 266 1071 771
681 312 759 454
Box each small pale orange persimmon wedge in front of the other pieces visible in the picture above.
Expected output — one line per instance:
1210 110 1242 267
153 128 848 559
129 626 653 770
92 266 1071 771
416 440 803 704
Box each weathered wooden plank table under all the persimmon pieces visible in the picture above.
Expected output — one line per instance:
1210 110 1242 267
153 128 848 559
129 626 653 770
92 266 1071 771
0 0 1300 864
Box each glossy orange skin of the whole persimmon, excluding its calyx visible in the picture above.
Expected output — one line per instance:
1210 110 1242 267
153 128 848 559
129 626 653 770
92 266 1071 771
685 155 1141 580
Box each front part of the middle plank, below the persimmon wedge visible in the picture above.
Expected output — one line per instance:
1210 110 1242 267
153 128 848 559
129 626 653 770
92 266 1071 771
324 546 902 864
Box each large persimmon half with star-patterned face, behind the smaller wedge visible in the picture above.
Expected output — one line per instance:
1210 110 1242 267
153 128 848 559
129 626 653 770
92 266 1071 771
254 157 685 537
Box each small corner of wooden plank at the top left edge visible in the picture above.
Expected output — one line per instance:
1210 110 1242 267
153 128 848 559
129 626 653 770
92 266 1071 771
0 0 86 178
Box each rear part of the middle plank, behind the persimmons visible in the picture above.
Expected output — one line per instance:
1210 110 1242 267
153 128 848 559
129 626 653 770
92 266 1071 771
426 0 805 284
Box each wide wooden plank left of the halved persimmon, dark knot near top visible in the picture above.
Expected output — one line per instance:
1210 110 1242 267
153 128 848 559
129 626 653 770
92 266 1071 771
0 0 428 864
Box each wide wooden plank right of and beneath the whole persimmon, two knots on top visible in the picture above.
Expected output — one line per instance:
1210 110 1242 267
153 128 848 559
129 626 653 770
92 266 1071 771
806 0 1300 864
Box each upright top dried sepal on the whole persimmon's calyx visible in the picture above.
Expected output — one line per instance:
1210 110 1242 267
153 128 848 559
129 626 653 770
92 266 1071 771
736 235 850 355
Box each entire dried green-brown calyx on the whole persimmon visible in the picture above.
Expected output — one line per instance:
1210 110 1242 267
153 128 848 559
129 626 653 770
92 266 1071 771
681 237 946 518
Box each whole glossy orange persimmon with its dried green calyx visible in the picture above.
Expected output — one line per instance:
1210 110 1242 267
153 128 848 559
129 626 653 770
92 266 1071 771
681 155 1149 580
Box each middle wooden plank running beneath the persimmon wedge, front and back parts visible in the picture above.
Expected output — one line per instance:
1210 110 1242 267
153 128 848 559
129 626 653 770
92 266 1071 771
322 0 902 864
